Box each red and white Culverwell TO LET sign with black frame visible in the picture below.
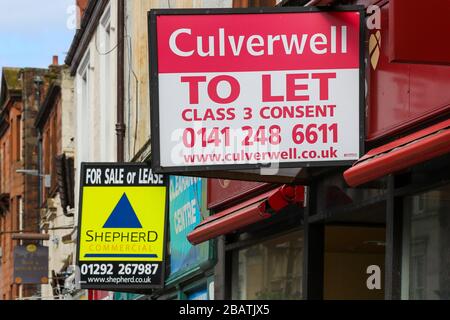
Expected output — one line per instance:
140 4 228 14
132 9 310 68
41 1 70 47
149 7 364 172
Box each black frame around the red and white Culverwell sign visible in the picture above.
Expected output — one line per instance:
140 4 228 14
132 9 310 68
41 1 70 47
148 5 366 174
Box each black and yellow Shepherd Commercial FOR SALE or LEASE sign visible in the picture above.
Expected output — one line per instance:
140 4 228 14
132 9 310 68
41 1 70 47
77 163 168 290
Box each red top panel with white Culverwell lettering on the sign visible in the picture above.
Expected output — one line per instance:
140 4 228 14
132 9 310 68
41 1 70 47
156 12 360 74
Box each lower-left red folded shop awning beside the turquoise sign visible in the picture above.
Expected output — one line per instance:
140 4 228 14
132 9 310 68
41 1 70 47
187 185 305 245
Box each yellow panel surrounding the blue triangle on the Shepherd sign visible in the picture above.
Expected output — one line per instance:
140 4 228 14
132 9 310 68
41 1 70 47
79 186 166 261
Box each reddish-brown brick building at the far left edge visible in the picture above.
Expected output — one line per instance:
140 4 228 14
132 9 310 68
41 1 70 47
0 69 49 299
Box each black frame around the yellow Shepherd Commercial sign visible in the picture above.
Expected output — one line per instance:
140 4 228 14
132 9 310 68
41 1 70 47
75 162 169 291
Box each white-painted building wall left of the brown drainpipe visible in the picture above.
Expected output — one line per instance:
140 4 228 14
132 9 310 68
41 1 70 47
66 0 119 298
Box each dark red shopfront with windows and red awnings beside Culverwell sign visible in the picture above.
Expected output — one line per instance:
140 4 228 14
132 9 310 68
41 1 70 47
189 0 450 299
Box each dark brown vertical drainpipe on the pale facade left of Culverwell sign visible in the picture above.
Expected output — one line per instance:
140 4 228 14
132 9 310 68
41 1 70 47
116 0 126 162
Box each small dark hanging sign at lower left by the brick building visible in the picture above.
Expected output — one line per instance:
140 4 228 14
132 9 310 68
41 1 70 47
14 244 48 284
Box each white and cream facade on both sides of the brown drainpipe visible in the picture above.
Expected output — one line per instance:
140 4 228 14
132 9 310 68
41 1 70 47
66 0 232 299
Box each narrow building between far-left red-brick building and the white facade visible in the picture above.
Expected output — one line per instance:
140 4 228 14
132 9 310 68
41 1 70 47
35 57 76 299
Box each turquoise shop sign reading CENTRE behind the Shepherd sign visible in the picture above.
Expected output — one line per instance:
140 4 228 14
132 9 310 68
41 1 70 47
169 176 209 275
